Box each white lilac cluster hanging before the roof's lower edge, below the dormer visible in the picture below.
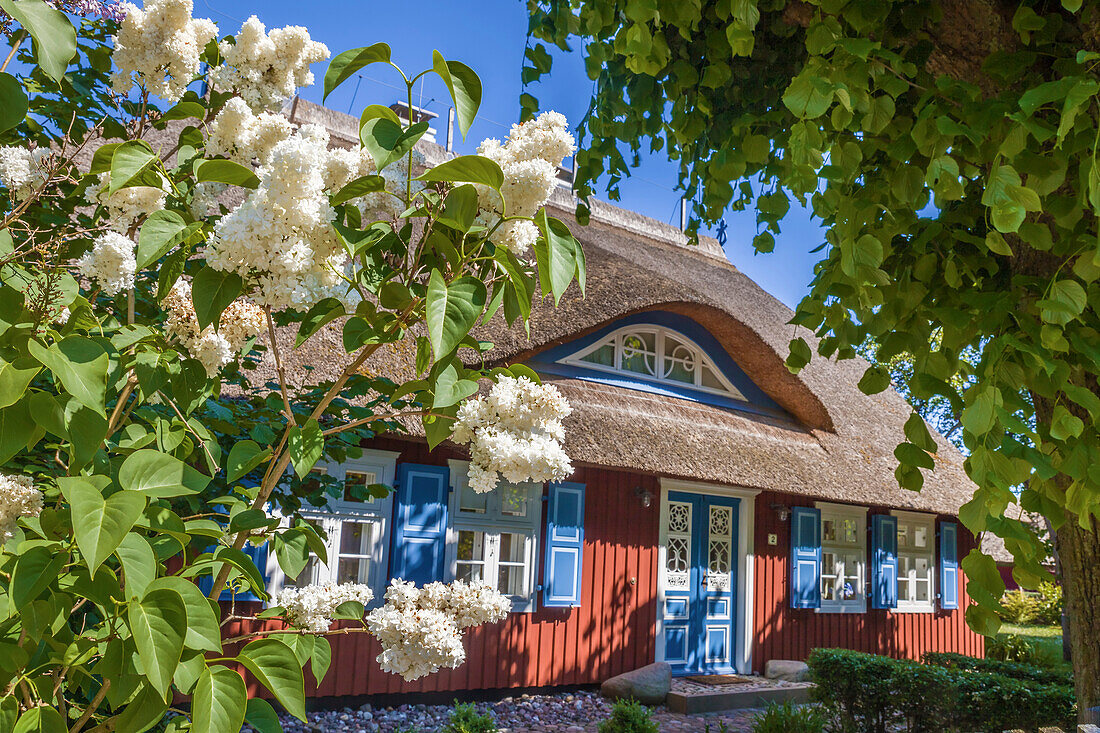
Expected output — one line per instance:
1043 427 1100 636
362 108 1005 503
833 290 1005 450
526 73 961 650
452 376 573 493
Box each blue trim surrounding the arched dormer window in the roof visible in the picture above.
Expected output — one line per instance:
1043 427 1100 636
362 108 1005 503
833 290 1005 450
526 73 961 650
527 310 793 422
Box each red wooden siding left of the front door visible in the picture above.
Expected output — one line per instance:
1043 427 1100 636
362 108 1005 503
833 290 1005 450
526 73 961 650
227 440 659 697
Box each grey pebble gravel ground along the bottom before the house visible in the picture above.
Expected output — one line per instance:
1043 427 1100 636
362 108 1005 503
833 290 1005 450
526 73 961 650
282 691 759 733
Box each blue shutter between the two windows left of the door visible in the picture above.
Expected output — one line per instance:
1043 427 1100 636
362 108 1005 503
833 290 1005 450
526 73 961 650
392 463 450 584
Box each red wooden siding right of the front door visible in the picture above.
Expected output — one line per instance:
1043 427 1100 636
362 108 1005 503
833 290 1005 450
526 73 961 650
752 492 985 671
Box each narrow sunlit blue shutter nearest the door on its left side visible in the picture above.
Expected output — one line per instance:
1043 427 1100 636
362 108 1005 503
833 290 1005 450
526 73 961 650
542 482 584 609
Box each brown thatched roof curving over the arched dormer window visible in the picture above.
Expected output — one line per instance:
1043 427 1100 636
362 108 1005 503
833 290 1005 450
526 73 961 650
234 102 974 514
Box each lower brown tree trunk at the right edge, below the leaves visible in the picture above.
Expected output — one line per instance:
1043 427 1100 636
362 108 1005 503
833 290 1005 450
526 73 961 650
1054 517 1100 723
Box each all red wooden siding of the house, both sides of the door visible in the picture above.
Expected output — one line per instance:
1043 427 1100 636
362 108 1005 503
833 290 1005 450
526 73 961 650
227 433 983 697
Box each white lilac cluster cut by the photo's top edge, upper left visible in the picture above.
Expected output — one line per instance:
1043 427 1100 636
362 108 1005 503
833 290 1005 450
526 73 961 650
111 0 218 103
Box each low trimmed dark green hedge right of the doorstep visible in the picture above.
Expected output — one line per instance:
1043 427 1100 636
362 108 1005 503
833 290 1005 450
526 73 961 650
806 649 1077 733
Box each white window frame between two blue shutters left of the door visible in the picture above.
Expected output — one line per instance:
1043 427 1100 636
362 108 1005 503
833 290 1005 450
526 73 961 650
444 459 542 613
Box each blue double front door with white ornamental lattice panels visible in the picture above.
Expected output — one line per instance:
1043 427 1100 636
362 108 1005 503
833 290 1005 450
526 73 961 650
660 491 739 675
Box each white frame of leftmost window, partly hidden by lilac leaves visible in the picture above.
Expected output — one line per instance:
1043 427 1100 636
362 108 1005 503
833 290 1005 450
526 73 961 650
267 449 400 606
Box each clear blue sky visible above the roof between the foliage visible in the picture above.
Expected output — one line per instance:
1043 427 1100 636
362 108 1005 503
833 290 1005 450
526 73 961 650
204 0 823 307
